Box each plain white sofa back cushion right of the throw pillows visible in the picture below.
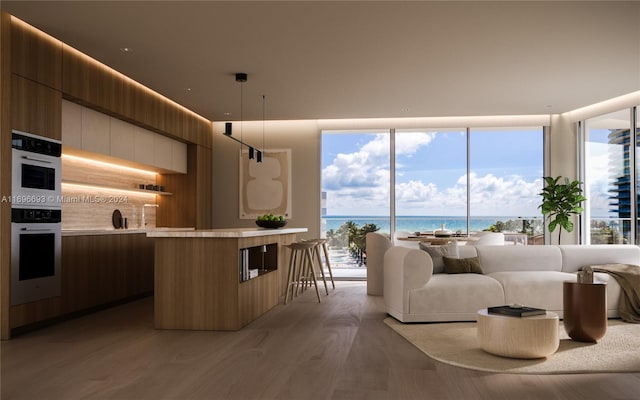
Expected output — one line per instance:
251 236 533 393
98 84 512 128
476 246 562 274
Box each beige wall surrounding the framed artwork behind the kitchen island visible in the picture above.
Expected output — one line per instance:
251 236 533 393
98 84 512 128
213 121 321 238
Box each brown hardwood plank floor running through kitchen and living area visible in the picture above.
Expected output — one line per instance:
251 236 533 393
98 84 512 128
0 282 640 400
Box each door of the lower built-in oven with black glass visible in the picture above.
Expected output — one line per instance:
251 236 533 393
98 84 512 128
11 222 62 305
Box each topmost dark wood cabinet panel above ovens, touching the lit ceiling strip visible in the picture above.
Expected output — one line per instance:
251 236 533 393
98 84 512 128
11 19 62 90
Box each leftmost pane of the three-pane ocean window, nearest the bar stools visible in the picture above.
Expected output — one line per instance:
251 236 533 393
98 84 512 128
321 130 391 277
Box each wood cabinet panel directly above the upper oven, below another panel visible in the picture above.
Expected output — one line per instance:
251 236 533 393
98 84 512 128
11 75 62 140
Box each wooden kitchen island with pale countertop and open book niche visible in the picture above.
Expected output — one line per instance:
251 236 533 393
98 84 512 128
147 228 307 330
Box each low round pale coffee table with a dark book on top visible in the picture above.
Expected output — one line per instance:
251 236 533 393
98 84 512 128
478 309 560 358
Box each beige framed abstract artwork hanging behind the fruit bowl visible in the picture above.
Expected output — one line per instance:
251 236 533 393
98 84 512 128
239 149 291 219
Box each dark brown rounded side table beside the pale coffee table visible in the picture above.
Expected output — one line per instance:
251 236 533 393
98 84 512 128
562 281 607 342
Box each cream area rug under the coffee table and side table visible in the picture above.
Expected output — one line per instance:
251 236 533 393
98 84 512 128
384 318 640 374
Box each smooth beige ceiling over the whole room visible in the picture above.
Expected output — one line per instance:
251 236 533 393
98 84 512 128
1 1 640 121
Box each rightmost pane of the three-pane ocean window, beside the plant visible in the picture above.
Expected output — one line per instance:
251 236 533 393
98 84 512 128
469 127 544 244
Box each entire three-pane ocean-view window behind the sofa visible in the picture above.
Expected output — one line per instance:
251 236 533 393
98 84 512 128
321 127 544 276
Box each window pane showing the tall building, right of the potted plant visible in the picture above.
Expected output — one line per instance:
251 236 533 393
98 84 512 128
583 110 637 244
